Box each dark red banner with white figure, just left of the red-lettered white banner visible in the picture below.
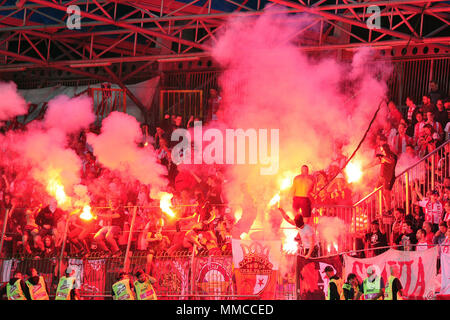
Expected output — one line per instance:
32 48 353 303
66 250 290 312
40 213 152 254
297 256 342 300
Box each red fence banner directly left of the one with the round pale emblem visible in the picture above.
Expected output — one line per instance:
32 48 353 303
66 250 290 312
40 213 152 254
152 257 191 300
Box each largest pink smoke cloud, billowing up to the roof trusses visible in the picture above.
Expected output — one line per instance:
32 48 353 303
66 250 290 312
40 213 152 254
207 6 391 238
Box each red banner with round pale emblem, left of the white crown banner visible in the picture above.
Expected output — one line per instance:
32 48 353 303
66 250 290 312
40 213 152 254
194 256 234 300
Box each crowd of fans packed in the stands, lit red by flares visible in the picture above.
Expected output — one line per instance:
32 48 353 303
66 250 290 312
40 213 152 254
0 84 450 264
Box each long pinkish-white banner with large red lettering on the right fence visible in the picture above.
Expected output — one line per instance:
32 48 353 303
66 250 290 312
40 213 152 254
344 247 438 299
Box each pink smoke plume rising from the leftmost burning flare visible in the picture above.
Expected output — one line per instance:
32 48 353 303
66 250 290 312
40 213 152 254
2 91 95 201
